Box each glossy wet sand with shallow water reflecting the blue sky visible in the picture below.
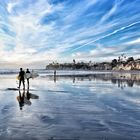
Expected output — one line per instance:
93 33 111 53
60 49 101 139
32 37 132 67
0 74 140 140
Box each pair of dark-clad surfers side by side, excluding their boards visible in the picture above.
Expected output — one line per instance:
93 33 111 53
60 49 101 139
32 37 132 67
18 68 30 90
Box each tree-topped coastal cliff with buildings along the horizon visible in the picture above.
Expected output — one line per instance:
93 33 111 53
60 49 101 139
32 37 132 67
46 56 140 70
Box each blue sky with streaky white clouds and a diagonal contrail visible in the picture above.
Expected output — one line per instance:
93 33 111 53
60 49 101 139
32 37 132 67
0 0 140 68
